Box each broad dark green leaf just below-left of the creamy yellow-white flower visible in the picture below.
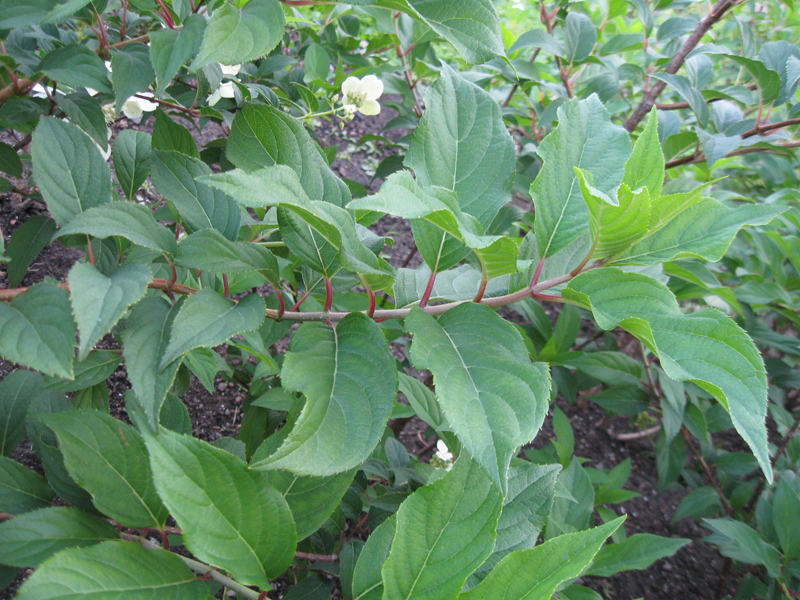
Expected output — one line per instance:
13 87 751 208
225 104 351 206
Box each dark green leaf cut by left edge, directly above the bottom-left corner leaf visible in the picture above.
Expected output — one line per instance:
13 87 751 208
0 506 119 567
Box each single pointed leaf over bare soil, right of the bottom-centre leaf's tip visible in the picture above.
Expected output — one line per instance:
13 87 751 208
586 533 692 577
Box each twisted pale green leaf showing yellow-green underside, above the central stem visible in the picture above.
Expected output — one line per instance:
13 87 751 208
348 171 519 279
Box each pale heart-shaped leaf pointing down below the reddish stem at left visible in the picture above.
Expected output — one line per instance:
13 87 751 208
68 263 153 360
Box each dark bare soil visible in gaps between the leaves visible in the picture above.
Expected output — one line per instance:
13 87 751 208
0 101 748 600
